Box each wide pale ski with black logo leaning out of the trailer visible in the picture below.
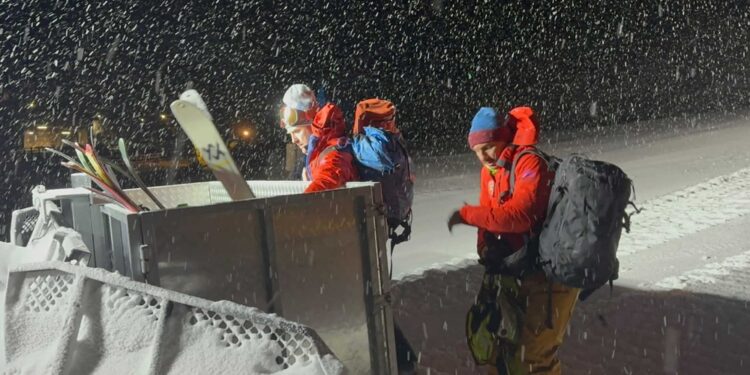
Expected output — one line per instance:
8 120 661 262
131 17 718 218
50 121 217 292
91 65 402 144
169 90 255 200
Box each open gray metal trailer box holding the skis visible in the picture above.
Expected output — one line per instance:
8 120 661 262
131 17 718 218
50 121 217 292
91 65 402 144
23 180 397 374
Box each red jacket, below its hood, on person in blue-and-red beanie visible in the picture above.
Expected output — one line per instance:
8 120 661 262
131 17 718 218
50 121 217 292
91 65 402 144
461 146 555 254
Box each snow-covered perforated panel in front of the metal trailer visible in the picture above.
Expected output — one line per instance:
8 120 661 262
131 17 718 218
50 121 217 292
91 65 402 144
5 262 343 375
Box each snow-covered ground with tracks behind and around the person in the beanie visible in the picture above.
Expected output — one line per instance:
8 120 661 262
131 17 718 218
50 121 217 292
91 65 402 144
394 115 750 374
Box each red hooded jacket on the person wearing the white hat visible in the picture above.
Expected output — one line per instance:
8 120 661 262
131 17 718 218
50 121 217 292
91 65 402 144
305 103 359 193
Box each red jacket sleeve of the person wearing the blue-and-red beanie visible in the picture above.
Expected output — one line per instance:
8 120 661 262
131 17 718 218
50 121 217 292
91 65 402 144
461 155 552 233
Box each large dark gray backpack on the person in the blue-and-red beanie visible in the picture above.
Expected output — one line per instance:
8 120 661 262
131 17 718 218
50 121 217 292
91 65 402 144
510 149 637 299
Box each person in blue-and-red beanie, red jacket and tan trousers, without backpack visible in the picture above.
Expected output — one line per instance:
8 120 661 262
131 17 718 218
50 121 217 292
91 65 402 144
448 107 579 375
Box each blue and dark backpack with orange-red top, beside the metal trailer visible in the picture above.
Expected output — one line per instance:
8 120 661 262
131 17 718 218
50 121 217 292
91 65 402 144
351 99 414 250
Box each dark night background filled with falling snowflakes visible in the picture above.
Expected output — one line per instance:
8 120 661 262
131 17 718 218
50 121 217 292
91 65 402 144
0 0 750 236
